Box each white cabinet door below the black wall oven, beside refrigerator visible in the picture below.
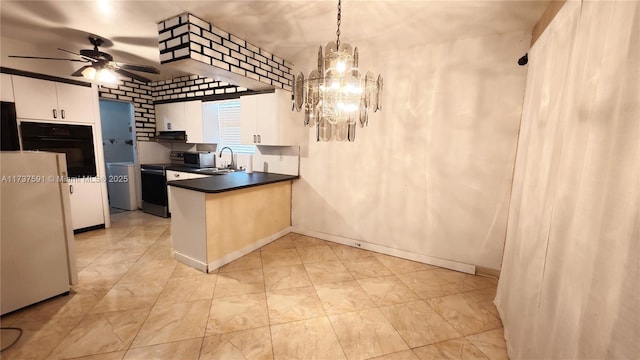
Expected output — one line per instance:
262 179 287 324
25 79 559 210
69 178 104 230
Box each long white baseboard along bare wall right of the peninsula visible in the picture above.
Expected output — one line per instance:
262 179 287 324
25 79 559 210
291 227 476 275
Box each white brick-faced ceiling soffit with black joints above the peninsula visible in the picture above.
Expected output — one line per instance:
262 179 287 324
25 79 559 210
158 13 293 91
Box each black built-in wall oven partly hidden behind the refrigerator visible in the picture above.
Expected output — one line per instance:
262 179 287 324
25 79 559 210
20 121 97 177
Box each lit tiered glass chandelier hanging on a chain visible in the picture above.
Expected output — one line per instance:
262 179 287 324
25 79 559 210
293 0 382 141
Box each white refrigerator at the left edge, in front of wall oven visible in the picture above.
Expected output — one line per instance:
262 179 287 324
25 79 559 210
0 151 77 315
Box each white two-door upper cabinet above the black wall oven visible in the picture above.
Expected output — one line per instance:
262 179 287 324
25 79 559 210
13 75 96 123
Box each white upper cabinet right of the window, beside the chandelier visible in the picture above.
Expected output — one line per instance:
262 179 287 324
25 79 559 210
240 90 304 145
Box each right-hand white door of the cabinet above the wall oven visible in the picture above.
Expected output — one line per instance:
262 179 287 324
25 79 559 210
55 83 97 123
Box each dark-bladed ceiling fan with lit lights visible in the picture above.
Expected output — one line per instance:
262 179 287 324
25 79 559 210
9 36 160 83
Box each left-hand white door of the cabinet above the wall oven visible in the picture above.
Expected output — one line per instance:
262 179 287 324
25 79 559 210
13 75 60 120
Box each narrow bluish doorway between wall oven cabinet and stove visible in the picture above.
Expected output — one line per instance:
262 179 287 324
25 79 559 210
100 99 138 214
